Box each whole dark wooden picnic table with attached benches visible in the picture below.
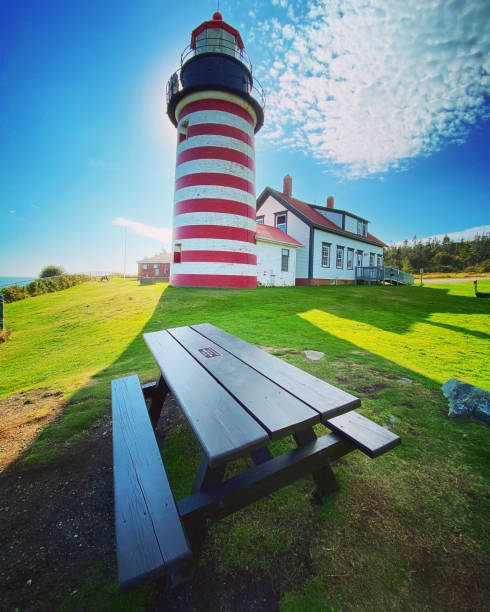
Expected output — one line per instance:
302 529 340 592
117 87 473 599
112 323 400 591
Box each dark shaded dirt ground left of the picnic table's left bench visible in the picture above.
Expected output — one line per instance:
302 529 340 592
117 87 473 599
0 412 114 610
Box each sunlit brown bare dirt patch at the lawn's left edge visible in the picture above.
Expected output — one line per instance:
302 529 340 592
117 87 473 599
0 389 64 471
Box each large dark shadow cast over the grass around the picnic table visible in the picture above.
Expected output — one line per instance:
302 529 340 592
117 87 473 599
1 287 490 610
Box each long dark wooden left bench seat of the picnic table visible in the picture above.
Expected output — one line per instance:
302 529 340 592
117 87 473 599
112 376 192 591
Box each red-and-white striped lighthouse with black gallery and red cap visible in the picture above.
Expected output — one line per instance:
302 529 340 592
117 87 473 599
167 12 264 289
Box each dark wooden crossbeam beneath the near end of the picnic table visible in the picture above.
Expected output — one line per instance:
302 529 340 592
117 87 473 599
177 434 355 532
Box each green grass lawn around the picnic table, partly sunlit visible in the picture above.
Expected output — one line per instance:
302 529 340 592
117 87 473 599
0 280 490 610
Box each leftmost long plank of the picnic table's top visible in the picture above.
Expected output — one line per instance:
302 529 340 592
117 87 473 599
143 330 268 467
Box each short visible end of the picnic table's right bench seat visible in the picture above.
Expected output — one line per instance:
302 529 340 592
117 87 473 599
325 410 401 458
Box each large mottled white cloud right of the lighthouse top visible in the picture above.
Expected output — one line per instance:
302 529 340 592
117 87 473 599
256 0 490 176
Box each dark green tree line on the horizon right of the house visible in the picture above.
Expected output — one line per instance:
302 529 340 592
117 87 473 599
384 235 490 274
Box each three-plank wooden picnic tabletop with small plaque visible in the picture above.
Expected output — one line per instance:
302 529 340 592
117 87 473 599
143 323 361 466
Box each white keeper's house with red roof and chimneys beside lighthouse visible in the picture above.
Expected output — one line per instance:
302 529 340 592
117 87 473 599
256 174 386 285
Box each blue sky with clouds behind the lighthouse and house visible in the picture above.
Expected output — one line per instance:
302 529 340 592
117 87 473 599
0 0 490 276
